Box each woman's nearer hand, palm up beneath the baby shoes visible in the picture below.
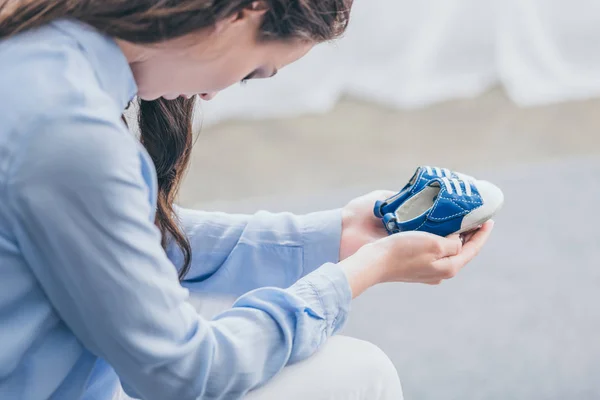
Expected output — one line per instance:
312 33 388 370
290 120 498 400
339 221 494 297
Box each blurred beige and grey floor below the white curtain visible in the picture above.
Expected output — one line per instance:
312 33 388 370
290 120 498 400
181 86 600 400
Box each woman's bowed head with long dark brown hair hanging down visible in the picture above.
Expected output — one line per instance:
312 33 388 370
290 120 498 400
0 0 353 276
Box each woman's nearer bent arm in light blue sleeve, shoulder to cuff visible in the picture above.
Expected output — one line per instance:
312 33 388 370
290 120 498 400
5 113 351 400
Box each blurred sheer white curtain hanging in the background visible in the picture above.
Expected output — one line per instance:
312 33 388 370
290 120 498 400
201 0 600 125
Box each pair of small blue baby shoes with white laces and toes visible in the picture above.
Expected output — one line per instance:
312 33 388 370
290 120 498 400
375 167 504 236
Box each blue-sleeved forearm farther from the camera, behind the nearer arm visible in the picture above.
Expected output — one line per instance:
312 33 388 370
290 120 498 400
167 208 342 296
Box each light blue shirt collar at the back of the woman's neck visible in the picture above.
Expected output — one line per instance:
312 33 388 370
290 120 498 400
53 20 138 109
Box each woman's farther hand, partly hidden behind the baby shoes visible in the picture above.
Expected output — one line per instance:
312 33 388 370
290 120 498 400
340 190 395 261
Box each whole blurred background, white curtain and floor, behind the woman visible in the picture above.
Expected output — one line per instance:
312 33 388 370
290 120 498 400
180 0 600 399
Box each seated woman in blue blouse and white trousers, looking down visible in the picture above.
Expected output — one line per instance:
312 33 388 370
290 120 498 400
0 0 491 400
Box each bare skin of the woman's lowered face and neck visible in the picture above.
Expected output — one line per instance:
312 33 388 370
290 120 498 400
119 9 313 100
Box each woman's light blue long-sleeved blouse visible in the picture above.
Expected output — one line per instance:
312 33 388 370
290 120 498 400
0 20 351 400
